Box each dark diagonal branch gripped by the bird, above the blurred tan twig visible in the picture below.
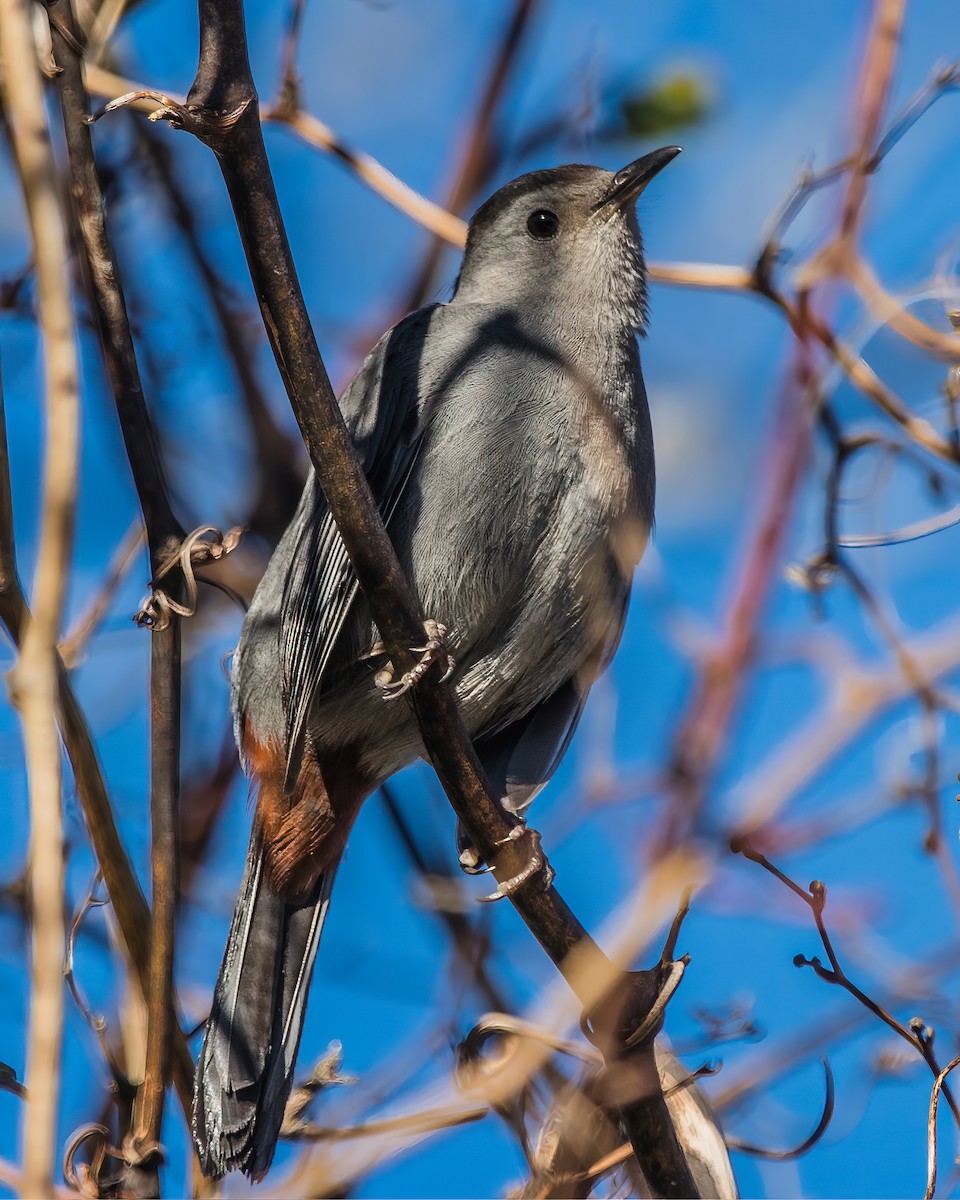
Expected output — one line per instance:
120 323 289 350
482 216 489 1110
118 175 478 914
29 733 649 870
186 0 595 965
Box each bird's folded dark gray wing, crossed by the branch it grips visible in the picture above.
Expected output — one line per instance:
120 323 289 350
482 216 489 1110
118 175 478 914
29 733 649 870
280 305 439 786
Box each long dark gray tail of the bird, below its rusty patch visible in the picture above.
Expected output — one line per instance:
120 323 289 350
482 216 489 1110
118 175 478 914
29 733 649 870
193 834 336 1180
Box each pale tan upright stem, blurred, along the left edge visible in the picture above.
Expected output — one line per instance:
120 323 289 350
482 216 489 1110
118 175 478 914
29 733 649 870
0 7 79 1195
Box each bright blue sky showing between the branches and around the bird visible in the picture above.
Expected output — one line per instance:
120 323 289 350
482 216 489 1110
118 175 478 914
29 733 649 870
0 0 960 1196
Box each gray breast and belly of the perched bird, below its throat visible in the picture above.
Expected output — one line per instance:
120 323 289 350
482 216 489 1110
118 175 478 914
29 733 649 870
397 305 653 732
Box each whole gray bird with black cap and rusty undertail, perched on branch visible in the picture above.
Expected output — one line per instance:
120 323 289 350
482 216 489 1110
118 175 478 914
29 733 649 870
193 146 679 1178
